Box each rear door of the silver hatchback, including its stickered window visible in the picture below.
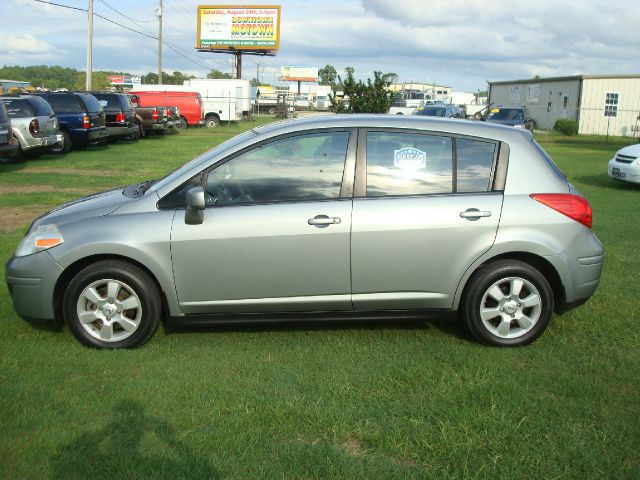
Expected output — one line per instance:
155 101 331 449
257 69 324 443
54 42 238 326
351 130 503 310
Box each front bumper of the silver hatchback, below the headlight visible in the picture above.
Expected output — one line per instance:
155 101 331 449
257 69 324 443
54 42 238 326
5 250 63 320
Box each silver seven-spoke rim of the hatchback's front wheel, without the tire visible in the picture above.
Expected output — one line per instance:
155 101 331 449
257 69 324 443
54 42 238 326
76 279 142 342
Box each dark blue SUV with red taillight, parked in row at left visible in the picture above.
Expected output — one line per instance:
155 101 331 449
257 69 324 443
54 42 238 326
33 92 109 152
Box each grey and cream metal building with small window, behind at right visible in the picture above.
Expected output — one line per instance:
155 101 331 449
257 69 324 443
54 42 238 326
489 74 640 136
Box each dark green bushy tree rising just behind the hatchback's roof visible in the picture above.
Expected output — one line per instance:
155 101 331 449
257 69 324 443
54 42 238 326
329 67 393 113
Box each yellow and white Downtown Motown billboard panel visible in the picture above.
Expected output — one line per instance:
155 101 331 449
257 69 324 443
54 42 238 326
196 5 280 50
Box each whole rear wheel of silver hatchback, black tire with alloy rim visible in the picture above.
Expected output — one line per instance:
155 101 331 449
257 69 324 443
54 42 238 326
460 260 553 347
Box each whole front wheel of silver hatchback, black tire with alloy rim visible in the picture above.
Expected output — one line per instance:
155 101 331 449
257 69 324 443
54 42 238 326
62 260 161 349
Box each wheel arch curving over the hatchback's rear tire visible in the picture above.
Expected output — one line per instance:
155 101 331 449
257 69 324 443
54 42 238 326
454 251 566 314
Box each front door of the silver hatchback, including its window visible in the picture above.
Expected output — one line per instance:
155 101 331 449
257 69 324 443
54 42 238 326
171 131 353 314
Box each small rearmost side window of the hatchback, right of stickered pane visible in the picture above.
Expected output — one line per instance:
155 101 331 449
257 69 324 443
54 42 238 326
456 138 496 193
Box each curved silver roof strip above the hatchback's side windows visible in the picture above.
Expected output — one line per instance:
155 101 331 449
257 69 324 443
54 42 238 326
253 114 531 142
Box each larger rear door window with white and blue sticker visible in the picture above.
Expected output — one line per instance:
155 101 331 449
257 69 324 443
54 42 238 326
367 132 453 197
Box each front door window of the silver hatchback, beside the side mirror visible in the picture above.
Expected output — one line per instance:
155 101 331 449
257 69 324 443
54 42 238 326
206 132 349 205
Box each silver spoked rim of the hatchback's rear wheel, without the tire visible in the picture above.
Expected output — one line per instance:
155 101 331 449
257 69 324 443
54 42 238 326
480 277 542 338
